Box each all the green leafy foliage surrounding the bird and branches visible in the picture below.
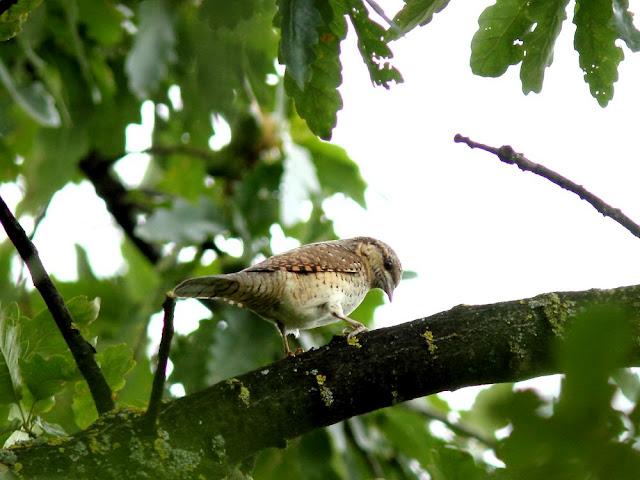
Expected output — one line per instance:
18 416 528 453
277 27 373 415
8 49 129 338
0 0 640 479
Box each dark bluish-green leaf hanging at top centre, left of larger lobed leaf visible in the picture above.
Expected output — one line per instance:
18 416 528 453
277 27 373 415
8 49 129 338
278 0 324 91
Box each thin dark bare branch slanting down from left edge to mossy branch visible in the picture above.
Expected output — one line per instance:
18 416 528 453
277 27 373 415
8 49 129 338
0 197 115 414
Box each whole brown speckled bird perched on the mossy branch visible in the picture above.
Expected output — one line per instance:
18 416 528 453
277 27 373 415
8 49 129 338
170 237 402 355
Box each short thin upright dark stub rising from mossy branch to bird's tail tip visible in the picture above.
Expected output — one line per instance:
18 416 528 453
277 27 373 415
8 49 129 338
144 295 176 433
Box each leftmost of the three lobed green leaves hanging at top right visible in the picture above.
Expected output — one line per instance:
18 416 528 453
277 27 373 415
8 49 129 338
471 0 533 77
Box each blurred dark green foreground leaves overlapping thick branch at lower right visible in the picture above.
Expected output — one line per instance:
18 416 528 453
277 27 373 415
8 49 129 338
493 304 640 479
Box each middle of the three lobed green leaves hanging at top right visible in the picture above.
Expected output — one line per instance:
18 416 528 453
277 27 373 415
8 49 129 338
520 0 569 95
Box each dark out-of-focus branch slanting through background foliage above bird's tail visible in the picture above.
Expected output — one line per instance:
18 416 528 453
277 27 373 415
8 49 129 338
80 151 160 264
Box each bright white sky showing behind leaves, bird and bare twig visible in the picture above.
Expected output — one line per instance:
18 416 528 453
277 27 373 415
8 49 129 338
3 0 640 408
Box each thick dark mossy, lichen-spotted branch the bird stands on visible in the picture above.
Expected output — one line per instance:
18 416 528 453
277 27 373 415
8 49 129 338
2 285 640 478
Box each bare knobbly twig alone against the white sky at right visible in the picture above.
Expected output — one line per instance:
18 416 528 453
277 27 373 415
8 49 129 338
454 134 640 238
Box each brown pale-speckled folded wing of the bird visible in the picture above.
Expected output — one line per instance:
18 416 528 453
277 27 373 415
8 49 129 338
244 241 362 273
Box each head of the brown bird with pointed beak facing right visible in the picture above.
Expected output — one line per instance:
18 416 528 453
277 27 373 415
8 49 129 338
354 237 402 301
